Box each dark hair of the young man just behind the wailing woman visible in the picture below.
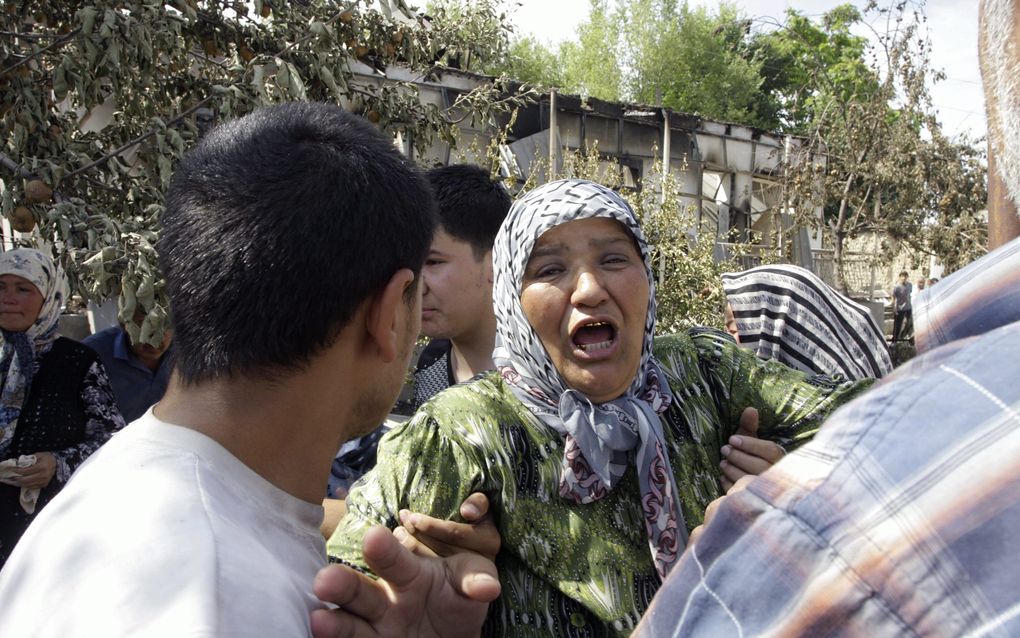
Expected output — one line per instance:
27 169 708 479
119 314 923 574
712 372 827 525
425 164 511 259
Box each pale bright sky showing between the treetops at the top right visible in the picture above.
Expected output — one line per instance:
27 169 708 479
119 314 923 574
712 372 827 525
508 0 985 137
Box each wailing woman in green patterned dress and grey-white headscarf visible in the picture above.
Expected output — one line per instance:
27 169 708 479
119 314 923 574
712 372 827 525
327 180 867 636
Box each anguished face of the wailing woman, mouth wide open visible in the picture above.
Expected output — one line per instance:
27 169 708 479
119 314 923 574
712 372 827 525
520 217 649 403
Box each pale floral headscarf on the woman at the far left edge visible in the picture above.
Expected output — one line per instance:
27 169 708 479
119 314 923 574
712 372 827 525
0 248 65 458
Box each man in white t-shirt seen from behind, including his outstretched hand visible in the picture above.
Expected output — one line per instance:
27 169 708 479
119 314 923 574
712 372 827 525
0 103 499 636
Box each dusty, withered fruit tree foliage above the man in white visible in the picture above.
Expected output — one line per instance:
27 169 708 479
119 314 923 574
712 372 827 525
0 0 534 341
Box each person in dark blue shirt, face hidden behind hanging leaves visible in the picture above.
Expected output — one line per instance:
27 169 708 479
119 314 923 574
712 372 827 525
82 308 173 423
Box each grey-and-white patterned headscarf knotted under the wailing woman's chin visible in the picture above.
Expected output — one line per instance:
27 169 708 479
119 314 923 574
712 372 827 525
493 180 686 578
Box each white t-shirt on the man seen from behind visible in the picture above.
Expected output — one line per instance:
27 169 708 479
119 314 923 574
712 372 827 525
0 409 325 638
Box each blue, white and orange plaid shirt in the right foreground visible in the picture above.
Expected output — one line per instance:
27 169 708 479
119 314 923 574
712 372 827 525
634 236 1020 638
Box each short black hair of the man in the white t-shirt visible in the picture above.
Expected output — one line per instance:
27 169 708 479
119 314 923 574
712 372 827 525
159 103 435 384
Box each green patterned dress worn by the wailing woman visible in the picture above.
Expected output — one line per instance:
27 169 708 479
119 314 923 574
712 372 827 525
327 329 871 637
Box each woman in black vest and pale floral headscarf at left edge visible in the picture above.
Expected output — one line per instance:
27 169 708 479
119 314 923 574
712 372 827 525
0 248 124 567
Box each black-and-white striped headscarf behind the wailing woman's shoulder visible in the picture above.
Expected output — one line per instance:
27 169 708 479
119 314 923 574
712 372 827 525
722 264 893 381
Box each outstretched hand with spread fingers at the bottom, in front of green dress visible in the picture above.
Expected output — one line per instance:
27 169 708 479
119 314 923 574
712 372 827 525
311 526 500 638
